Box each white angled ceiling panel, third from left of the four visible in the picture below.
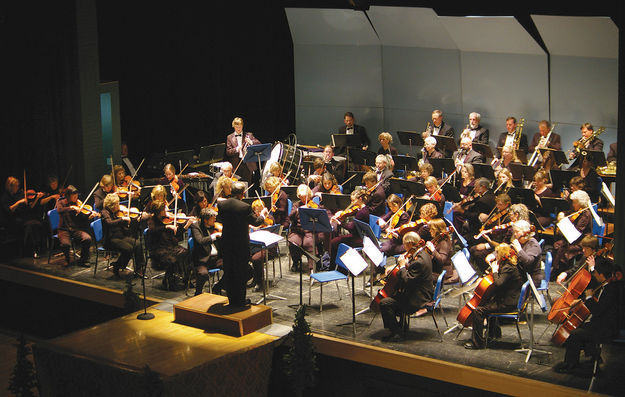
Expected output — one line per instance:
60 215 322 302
439 17 545 55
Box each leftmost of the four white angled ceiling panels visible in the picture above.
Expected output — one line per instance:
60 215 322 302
286 8 380 45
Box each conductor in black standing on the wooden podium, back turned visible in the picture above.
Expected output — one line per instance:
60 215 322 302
217 182 268 307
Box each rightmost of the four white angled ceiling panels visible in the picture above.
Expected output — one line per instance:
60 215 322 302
532 15 618 59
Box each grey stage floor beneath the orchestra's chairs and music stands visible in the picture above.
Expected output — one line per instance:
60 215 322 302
4 246 625 395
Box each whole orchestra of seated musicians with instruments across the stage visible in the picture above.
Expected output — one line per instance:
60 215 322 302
1 110 620 378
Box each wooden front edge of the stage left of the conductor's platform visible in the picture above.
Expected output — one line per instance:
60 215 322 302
0 264 161 308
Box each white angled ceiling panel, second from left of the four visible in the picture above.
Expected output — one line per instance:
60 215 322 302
368 6 457 50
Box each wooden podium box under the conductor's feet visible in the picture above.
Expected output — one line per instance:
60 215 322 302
174 294 272 336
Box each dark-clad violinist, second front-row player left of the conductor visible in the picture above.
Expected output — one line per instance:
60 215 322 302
145 201 188 291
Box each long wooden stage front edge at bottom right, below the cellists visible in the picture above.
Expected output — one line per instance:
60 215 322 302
313 333 598 397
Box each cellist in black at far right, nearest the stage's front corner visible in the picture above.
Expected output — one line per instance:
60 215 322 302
554 262 621 373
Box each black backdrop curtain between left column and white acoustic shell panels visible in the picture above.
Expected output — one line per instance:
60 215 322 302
97 0 295 159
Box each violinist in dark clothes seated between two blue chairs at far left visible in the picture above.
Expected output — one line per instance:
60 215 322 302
56 185 98 267
